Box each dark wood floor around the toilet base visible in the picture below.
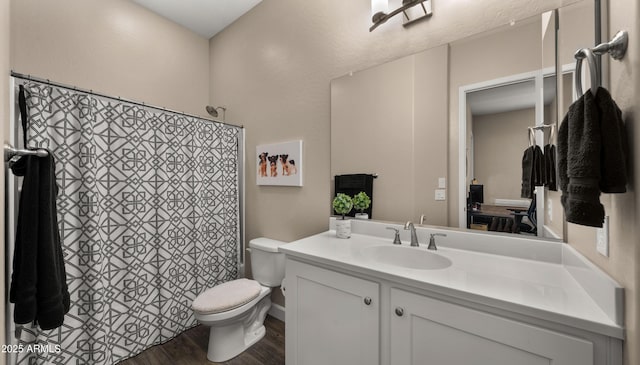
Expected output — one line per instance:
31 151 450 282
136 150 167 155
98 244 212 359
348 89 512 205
118 316 284 365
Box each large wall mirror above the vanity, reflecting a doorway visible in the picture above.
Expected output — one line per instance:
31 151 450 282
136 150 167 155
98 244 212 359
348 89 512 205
331 0 600 239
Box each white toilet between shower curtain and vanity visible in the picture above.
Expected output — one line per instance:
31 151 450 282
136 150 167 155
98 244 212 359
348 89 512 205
192 237 285 362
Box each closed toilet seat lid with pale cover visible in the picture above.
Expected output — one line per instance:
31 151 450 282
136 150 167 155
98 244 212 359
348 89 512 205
191 279 261 314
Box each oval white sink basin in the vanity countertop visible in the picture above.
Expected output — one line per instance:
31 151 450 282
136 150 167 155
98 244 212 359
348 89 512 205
362 246 451 270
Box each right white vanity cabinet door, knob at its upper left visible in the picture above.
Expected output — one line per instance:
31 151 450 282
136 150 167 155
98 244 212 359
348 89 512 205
390 289 593 365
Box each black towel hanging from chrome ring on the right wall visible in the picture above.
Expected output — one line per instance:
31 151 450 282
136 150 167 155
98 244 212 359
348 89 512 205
558 88 627 227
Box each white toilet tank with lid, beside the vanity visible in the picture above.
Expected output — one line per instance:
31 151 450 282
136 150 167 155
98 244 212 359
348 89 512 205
249 237 286 287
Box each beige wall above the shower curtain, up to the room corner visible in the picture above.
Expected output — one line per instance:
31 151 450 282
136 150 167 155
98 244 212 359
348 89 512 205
11 0 209 115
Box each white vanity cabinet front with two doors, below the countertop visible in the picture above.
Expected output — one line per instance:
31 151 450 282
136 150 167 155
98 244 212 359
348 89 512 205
285 257 622 365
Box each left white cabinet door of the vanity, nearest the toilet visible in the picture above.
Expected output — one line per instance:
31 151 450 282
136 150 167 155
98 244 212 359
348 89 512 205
285 260 380 365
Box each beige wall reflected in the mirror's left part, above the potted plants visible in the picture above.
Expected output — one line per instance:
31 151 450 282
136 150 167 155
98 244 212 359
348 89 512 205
331 45 448 225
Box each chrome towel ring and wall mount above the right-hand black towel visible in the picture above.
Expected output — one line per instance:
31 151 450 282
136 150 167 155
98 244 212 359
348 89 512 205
574 30 629 96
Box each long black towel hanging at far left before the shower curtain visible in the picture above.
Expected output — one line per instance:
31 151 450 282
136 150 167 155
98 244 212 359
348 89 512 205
9 153 69 330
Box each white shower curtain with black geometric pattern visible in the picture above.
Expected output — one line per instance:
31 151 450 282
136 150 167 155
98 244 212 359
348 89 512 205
13 82 240 364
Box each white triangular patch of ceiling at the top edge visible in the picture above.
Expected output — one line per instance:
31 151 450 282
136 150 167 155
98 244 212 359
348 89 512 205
133 0 262 39
